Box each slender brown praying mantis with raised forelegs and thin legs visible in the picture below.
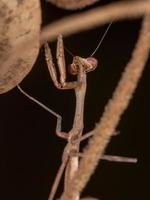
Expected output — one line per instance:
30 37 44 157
17 23 136 200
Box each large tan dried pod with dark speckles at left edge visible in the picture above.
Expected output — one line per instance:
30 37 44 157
0 0 41 93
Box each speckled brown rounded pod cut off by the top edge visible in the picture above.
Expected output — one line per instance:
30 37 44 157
47 0 99 10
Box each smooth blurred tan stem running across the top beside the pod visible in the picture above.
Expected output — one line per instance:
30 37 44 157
41 0 150 43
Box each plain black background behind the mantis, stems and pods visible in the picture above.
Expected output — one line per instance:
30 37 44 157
0 0 150 200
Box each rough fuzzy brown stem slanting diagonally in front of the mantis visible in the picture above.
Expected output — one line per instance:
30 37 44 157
61 15 150 200
